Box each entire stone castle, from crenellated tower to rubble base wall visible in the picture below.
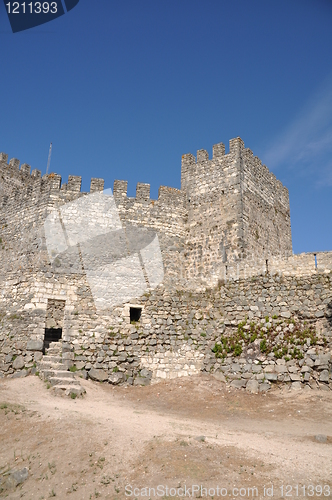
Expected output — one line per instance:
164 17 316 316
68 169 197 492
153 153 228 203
0 138 332 392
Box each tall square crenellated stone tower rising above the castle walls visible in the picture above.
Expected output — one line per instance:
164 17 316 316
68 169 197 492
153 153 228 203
181 137 292 281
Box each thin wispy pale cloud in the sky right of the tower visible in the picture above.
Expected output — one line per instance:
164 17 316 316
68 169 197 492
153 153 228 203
263 75 332 185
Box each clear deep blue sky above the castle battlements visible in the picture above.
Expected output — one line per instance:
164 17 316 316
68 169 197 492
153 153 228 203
0 0 332 253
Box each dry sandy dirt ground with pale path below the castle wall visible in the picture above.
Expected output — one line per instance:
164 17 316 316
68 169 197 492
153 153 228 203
0 375 332 500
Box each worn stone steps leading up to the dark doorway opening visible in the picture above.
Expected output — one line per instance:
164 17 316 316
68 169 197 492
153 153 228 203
38 341 85 399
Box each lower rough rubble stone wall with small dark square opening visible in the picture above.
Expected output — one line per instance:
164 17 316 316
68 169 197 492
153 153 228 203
0 273 332 387
